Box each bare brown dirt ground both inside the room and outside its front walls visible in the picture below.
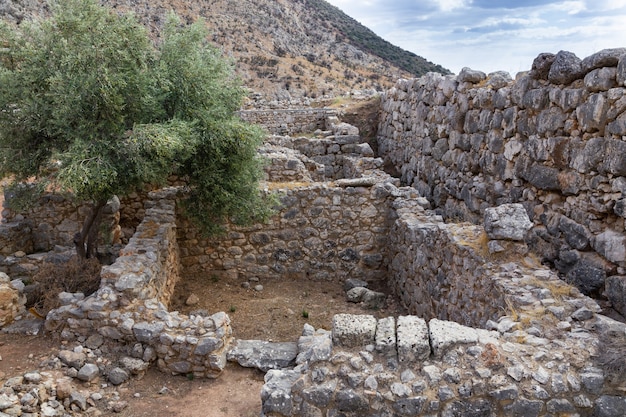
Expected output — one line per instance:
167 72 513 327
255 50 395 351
0 275 403 417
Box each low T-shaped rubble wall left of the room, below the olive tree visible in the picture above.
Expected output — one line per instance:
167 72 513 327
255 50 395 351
46 188 232 378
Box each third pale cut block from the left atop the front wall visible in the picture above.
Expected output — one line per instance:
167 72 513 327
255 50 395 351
397 316 430 364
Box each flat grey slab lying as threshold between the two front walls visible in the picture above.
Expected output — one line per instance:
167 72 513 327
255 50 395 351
226 340 298 372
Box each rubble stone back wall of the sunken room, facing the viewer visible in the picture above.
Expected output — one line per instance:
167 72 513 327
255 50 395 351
178 182 390 281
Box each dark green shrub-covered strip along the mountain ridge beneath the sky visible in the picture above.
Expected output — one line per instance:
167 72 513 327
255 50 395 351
306 0 450 77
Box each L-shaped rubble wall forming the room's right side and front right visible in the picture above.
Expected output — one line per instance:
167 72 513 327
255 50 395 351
261 190 626 417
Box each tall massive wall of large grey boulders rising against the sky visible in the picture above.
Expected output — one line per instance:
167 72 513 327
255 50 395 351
378 49 626 308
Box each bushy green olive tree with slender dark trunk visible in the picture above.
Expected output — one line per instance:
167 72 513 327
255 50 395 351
0 0 269 257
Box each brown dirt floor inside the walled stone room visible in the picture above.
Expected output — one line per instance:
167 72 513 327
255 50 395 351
170 274 404 342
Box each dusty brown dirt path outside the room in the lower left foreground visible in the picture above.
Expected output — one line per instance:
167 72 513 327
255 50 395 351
0 333 263 417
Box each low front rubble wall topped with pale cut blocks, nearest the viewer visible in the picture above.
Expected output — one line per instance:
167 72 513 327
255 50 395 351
261 315 626 417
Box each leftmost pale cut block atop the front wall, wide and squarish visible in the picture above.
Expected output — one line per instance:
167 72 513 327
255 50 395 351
332 314 376 348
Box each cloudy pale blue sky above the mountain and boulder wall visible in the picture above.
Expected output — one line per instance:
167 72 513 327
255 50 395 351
327 0 626 77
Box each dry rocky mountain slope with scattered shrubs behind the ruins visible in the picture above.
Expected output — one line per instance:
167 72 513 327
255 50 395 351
0 0 448 102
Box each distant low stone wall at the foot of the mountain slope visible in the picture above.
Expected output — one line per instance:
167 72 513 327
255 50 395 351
238 108 337 135
